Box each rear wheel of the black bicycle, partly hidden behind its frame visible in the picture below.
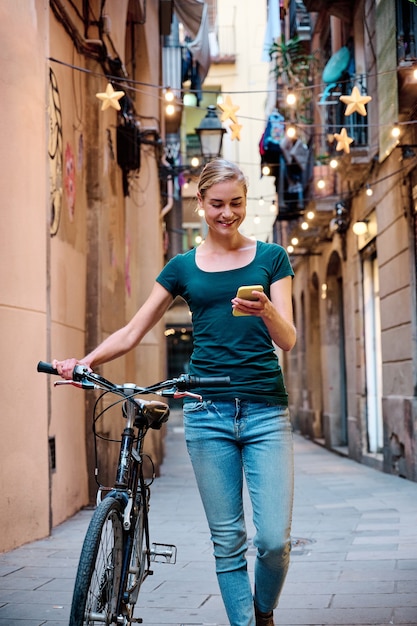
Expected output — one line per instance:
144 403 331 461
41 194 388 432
126 493 148 614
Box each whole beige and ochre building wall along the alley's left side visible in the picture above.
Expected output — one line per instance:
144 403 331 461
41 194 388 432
0 0 165 551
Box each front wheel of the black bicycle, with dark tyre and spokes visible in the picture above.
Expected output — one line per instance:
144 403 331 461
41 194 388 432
70 496 123 626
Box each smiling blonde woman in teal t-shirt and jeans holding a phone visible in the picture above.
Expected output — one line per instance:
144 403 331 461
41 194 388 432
54 159 296 626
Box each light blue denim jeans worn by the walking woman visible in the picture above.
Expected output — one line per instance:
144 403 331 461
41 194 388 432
184 399 294 626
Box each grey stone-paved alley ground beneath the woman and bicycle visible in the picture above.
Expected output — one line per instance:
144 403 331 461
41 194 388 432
0 413 417 626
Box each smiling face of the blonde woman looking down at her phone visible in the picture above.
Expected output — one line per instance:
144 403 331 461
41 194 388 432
198 180 246 234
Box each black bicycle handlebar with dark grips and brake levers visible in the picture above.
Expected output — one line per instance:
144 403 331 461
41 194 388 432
37 361 230 396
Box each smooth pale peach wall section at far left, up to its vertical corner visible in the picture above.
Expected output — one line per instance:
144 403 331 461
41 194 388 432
0 0 50 549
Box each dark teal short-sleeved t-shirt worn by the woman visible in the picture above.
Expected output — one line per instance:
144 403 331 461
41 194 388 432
156 241 294 406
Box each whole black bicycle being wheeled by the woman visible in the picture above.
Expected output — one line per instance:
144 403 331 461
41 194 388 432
37 361 230 626
